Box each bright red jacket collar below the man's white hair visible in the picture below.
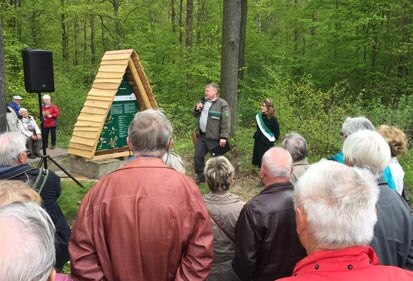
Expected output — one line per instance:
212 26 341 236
293 246 380 276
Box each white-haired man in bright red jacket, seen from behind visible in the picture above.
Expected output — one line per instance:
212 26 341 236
280 160 413 281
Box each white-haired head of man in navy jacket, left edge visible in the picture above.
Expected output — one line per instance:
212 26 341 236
0 132 26 166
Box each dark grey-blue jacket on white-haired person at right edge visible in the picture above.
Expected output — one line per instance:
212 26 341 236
370 179 413 270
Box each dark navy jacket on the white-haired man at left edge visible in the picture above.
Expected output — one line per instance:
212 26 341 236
0 164 71 269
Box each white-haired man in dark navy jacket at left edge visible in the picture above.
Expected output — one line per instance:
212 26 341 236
0 132 70 270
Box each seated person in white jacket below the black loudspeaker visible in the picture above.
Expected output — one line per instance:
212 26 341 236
19 107 42 159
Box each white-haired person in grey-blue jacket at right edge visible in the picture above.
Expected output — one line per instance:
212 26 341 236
343 130 413 270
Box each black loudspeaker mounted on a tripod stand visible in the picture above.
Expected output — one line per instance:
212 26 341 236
22 49 54 93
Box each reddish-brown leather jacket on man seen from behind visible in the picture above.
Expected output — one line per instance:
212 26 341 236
69 158 213 281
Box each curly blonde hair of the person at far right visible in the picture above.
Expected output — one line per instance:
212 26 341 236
377 125 408 157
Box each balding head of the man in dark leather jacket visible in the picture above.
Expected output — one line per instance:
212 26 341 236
261 147 293 178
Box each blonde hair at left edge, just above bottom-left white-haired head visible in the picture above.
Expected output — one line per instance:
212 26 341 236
0 180 42 207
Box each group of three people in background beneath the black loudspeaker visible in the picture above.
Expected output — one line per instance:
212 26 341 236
6 92 60 156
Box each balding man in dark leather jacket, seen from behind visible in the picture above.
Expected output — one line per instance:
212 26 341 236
232 147 305 281
